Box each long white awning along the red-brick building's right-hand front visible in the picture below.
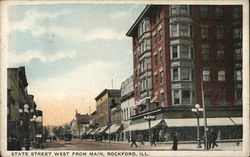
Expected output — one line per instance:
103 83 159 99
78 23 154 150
164 117 242 127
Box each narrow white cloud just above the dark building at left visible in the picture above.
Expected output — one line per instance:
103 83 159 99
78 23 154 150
10 51 76 65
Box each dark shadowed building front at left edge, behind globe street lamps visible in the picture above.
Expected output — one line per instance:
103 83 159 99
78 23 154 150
7 67 43 150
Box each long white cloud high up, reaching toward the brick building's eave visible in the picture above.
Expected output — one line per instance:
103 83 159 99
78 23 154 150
10 9 125 43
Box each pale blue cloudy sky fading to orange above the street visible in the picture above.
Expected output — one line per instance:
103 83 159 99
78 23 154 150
8 3 146 125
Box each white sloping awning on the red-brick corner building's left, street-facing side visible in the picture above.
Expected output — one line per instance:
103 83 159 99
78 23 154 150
123 119 165 132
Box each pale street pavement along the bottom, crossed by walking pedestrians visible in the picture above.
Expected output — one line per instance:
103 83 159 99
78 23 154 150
45 140 242 151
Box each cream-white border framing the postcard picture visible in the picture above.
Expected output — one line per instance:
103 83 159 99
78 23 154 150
0 0 250 157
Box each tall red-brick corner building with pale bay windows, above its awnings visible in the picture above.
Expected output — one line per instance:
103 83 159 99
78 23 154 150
126 5 242 140
